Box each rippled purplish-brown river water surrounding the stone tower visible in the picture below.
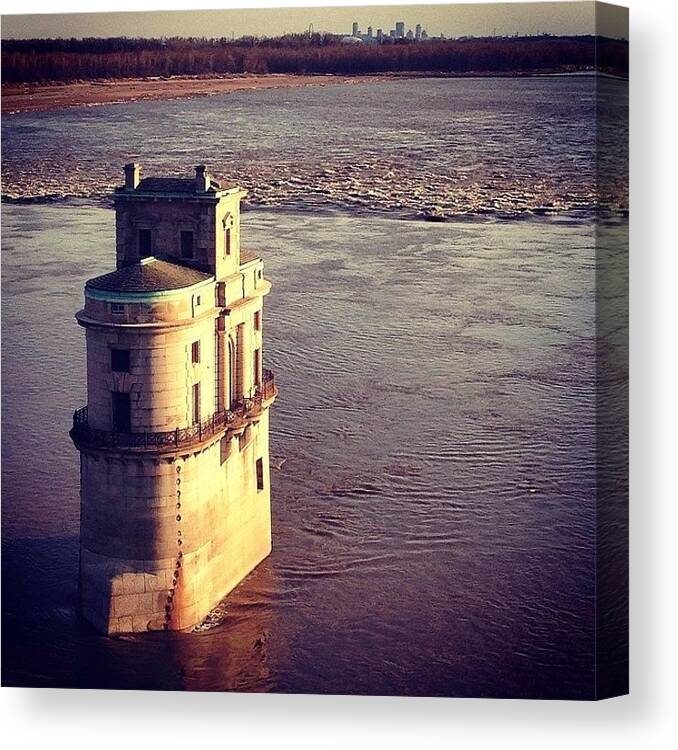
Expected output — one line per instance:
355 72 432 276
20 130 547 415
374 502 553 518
2 77 626 698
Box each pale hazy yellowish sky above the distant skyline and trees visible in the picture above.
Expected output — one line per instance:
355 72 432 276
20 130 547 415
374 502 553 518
2 0 628 39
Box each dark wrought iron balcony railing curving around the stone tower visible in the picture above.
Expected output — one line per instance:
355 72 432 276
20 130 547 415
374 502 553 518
71 370 277 449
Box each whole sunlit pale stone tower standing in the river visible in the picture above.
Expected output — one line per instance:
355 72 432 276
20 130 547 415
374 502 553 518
71 164 276 634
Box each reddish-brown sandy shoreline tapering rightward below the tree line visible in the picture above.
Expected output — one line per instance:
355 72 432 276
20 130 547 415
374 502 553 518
1 74 381 114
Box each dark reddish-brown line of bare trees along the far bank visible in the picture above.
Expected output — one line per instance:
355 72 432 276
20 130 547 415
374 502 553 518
2 34 628 83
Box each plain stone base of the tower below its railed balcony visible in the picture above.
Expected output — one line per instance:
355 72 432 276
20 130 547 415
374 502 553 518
80 409 271 634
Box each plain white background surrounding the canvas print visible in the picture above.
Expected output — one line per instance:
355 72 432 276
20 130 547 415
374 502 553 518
0 0 678 750
